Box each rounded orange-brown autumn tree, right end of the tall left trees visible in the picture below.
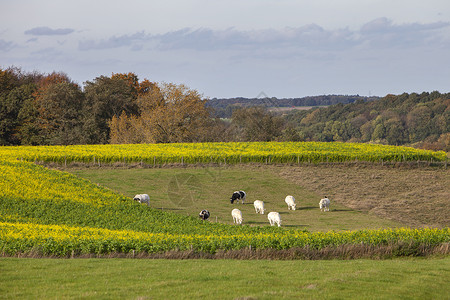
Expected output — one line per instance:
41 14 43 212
110 83 211 143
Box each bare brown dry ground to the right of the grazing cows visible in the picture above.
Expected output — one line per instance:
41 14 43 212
278 164 450 228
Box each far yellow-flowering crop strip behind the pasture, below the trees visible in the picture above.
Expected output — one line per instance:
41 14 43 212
0 142 446 164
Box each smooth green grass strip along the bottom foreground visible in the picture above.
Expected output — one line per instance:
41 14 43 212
0 257 450 299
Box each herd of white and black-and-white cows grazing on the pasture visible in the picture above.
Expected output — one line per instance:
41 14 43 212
133 191 330 227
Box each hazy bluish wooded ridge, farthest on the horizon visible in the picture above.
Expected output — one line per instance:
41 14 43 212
207 95 379 118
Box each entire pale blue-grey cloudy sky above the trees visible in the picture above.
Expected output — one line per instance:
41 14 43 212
0 0 450 98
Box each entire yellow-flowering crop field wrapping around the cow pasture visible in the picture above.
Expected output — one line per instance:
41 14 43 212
0 143 450 256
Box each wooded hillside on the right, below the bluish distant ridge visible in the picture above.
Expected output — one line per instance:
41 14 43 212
286 91 450 151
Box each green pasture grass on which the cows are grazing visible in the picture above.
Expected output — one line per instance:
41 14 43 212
69 166 401 231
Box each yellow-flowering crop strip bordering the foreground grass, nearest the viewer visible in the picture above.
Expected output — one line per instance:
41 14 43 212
0 222 450 256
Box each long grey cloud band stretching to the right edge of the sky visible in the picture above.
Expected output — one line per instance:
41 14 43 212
78 18 450 56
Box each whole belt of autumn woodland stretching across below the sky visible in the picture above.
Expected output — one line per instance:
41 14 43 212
0 67 450 152
